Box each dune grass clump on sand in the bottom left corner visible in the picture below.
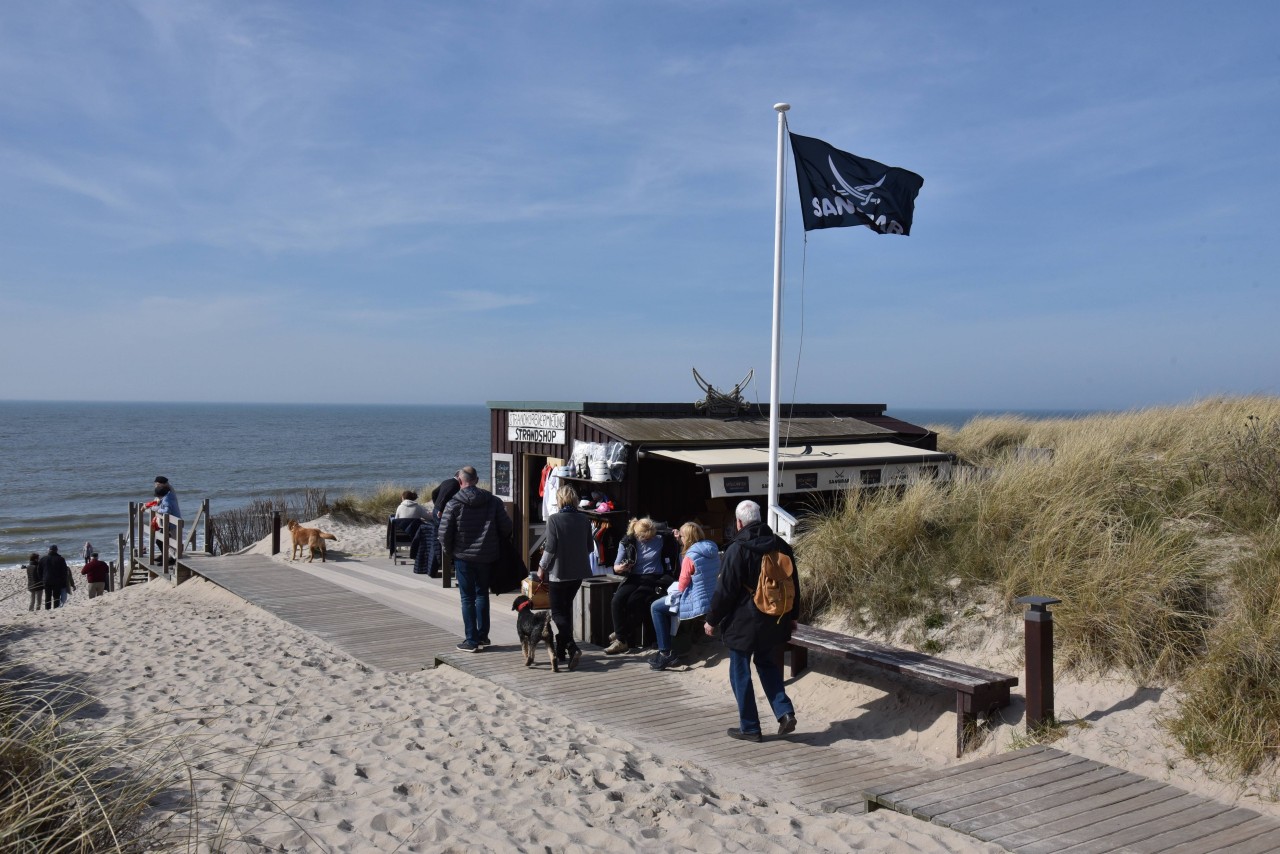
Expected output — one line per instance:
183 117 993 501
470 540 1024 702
0 665 378 854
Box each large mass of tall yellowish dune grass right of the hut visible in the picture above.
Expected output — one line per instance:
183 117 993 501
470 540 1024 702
797 397 1280 771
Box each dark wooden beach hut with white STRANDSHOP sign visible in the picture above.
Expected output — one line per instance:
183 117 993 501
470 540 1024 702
488 401 954 556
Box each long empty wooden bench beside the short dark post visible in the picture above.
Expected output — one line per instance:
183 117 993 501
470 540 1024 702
786 625 1018 757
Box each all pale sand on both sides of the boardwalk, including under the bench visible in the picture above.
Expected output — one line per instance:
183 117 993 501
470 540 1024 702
0 519 1280 851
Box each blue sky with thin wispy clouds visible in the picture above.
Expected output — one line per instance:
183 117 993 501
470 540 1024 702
0 0 1280 408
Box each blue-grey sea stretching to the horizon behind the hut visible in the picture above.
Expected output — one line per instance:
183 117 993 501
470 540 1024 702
0 401 1083 568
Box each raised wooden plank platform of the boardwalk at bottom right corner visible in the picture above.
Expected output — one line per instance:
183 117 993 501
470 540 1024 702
865 746 1280 854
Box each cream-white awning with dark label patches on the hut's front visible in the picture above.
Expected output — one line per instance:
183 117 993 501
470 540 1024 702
645 442 952 498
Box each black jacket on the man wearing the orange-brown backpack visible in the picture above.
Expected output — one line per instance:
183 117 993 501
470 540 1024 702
707 522 800 653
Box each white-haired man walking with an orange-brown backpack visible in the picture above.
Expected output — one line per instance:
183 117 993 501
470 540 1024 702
704 501 800 741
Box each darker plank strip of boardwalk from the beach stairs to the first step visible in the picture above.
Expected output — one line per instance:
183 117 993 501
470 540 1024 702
180 554 457 671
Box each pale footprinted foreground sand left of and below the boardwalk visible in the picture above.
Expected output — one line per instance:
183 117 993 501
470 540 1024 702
0 524 998 853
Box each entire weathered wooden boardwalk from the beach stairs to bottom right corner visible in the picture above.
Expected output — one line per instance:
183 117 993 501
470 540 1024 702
182 556 1280 854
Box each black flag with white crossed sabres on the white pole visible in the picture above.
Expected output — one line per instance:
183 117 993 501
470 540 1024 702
791 133 924 234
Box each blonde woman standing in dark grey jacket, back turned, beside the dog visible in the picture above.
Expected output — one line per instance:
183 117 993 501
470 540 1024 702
538 484 595 670
